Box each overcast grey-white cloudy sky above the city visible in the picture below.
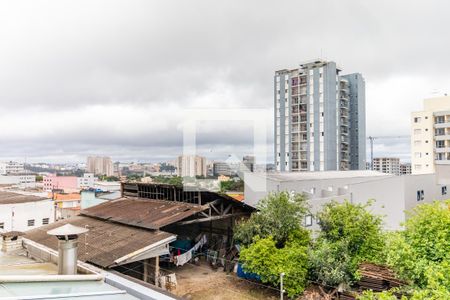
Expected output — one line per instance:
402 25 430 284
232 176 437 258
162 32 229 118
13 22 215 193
0 0 450 162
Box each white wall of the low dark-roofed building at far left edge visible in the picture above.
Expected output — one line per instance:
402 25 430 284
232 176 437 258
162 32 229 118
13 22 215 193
0 199 55 232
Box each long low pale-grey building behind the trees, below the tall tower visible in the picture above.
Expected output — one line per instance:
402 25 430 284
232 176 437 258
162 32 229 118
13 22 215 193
244 170 449 230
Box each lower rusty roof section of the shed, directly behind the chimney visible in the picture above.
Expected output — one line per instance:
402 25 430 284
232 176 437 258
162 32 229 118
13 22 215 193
26 216 175 268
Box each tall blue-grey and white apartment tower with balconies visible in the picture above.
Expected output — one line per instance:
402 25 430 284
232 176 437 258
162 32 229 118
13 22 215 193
274 60 366 172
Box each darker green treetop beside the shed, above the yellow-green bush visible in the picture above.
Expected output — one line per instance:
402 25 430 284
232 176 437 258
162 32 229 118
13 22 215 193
234 192 309 248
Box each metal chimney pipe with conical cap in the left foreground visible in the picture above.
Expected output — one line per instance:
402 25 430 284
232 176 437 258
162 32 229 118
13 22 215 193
47 224 89 275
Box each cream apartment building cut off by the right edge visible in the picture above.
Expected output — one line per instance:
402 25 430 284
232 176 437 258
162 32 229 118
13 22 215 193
411 96 450 174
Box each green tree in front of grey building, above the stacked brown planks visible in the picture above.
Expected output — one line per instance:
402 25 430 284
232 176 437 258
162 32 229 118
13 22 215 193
309 201 384 286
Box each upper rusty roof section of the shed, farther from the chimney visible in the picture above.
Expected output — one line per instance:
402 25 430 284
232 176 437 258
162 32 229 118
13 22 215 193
81 197 208 229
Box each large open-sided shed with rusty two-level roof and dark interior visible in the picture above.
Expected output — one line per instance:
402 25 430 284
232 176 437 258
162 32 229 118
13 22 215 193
26 183 254 287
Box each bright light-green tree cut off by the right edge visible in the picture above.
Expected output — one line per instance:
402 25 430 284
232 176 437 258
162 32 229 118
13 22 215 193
385 201 450 293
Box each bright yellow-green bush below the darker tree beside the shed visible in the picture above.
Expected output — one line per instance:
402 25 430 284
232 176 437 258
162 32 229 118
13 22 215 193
240 237 308 297
